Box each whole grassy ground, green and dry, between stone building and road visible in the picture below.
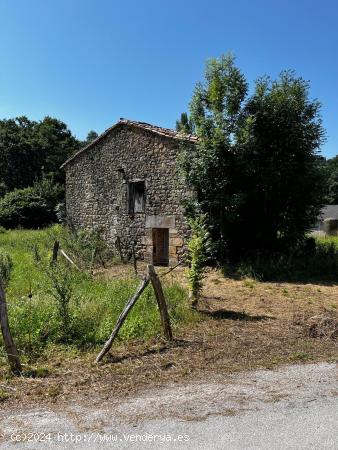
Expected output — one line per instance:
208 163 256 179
0 228 338 408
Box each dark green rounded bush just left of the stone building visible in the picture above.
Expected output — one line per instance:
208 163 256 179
0 180 63 228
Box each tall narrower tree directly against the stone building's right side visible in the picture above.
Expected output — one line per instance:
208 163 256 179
183 55 248 259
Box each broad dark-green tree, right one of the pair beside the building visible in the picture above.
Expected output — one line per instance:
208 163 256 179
237 71 325 252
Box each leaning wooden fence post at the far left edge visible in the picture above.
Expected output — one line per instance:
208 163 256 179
0 280 22 375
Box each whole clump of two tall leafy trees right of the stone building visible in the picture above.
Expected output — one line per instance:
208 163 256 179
183 55 324 259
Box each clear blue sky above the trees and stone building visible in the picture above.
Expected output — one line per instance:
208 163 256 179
0 0 338 157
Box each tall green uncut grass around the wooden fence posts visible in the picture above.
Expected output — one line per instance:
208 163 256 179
0 226 197 353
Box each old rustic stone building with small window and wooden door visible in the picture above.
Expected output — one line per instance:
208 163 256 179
62 119 196 265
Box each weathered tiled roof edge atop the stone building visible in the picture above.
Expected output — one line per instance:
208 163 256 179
61 118 197 169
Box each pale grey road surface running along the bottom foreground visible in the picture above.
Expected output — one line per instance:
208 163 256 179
0 363 338 449
